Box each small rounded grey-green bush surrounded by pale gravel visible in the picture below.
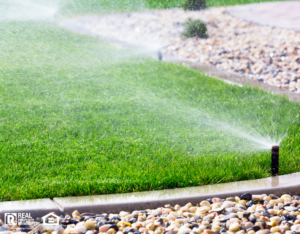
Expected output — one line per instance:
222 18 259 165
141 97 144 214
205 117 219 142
182 18 208 38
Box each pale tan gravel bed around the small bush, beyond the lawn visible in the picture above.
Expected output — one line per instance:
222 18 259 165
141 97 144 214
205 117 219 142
62 7 300 93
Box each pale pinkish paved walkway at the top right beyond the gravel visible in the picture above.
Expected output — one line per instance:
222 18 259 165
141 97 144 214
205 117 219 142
229 1 300 31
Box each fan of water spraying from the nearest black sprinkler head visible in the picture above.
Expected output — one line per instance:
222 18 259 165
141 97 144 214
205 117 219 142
119 79 293 153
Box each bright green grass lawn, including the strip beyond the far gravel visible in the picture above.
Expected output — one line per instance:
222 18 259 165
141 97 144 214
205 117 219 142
0 0 300 201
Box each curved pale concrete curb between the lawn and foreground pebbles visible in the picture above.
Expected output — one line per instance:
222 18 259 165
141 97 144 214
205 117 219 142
0 172 300 217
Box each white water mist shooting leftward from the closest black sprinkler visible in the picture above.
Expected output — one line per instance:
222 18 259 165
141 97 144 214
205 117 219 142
139 89 288 152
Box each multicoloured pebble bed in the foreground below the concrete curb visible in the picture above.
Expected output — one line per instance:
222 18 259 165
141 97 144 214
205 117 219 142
0 193 300 234
